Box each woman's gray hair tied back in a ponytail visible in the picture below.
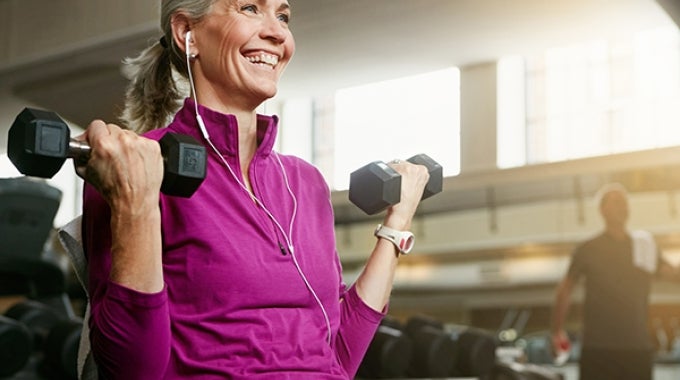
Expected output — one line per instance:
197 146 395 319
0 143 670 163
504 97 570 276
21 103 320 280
121 0 217 133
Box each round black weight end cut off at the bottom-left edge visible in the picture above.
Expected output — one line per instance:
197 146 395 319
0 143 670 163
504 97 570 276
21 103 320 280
0 315 33 378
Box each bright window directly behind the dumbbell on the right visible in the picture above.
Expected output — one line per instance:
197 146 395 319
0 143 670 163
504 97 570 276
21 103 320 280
327 68 460 190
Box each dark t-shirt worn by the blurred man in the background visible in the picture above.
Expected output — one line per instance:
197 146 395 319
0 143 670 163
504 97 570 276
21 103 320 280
569 234 654 349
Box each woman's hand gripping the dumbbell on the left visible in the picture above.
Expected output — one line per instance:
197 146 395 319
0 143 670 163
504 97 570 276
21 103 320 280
74 120 163 212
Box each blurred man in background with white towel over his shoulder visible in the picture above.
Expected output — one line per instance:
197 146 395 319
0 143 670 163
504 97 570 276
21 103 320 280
551 184 680 380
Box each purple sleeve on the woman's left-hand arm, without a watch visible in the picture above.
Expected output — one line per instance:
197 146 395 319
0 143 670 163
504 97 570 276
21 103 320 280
82 185 170 380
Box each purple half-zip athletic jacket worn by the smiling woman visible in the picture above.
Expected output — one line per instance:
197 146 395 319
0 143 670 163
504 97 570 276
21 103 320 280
83 99 384 380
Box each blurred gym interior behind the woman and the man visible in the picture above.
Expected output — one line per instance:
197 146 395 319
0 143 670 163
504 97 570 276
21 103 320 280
0 0 680 380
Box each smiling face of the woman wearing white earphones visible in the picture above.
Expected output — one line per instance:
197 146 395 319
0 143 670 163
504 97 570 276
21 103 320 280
192 0 295 105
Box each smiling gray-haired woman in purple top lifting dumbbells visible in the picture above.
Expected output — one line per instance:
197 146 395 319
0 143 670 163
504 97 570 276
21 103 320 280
77 0 428 379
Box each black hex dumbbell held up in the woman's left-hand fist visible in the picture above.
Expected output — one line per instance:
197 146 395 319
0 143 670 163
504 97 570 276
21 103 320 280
7 108 206 197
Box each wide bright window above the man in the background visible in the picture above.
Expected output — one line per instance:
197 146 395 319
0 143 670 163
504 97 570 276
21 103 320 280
498 27 680 168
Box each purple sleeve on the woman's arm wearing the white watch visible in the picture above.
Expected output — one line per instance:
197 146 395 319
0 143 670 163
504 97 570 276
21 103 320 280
334 286 387 379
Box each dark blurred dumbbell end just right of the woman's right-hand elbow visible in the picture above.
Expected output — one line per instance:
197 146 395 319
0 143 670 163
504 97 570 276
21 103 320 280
357 318 413 379
